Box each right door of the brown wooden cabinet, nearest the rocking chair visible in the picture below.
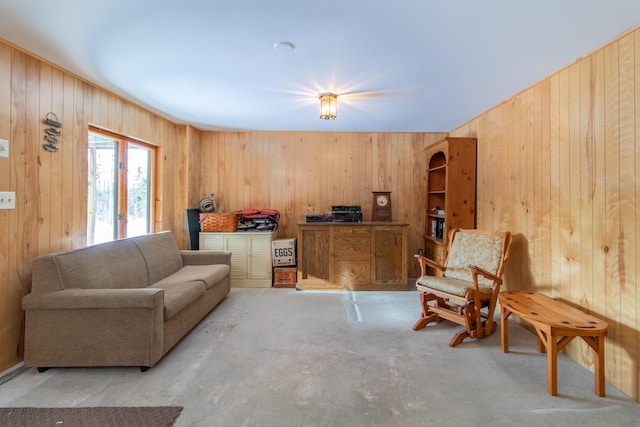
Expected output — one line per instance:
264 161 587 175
372 226 408 290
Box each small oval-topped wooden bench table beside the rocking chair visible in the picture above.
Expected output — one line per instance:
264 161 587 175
498 291 609 396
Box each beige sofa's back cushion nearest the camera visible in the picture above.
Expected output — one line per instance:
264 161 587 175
53 239 150 290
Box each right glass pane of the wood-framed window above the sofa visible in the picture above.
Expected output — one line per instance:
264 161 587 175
127 143 151 237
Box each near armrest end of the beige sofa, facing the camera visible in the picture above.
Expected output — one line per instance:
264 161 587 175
22 288 164 368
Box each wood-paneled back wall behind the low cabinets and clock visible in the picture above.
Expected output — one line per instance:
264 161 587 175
191 132 446 270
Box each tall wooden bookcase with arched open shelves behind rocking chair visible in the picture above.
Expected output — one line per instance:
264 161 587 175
424 137 476 270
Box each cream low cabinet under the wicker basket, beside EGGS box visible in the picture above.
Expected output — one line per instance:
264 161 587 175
200 231 273 288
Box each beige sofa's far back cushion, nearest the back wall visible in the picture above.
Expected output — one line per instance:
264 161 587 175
131 231 182 284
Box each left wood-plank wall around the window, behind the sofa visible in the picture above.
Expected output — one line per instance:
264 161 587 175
0 41 188 372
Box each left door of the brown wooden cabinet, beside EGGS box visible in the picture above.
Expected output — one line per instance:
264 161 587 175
298 226 335 287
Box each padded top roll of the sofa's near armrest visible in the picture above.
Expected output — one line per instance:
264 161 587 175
22 288 164 310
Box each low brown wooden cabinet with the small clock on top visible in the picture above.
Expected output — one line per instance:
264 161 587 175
296 222 409 291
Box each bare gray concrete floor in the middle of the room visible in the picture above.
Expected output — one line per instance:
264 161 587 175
0 288 640 427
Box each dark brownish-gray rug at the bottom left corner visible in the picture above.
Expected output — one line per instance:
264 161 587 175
0 406 182 427
